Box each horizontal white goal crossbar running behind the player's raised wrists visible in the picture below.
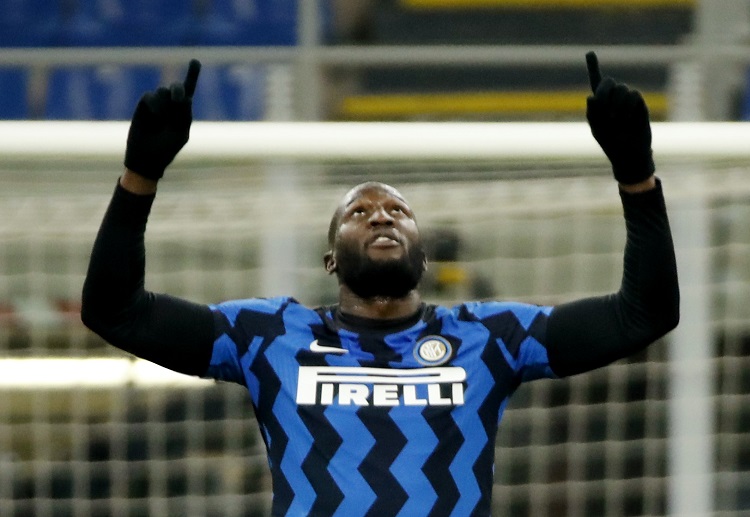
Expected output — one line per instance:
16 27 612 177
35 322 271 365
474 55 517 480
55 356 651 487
0 121 750 161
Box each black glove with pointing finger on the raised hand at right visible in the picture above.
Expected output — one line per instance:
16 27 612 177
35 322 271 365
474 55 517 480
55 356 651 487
586 52 655 185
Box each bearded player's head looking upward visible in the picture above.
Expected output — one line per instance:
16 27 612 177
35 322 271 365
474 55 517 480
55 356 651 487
328 183 425 297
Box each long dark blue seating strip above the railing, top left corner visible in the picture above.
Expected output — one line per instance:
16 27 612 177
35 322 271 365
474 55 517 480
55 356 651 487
0 0 297 47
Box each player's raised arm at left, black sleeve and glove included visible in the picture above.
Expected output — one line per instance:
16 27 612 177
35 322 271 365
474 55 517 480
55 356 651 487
81 60 214 375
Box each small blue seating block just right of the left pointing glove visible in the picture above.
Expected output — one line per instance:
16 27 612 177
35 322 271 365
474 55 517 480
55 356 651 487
193 65 267 120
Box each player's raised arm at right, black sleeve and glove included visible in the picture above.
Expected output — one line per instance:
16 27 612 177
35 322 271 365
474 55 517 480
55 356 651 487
547 52 680 376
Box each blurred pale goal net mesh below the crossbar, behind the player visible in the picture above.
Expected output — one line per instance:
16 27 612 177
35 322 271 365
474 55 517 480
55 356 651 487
0 123 750 516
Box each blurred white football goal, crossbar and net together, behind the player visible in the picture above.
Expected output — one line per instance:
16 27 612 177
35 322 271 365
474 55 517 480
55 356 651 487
0 122 750 517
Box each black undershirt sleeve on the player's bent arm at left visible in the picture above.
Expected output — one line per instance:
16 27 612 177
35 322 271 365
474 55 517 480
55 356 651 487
81 183 214 375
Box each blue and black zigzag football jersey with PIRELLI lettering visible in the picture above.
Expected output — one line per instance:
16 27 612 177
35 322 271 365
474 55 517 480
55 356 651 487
206 297 555 517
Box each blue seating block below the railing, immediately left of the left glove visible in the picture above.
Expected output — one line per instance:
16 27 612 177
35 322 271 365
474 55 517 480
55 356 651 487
44 65 161 120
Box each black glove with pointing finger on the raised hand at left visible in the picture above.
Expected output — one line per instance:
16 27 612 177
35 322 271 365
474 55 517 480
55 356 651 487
125 59 201 180
